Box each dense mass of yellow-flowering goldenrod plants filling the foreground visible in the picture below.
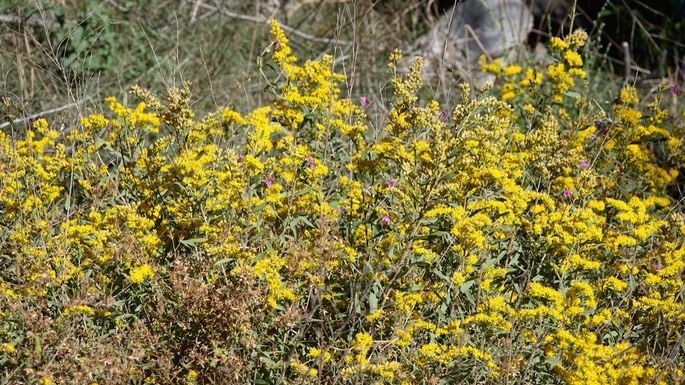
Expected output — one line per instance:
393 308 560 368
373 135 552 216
0 23 685 384
